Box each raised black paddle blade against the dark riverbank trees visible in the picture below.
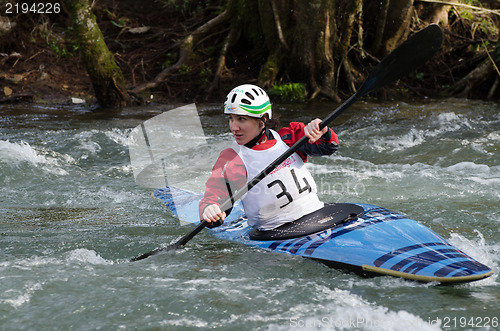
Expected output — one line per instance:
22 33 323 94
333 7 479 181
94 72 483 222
357 24 443 97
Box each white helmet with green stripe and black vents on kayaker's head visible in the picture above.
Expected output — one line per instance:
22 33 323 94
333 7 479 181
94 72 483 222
224 84 272 119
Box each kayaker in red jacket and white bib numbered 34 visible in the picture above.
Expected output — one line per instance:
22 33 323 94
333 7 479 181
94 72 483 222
199 84 338 231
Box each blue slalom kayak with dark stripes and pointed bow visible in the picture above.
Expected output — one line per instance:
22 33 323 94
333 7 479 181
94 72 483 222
153 187 493 284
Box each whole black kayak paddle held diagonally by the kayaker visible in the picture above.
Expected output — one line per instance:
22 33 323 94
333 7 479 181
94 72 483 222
131 24 443 261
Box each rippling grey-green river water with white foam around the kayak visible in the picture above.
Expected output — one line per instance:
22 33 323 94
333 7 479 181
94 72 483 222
0 100 500 330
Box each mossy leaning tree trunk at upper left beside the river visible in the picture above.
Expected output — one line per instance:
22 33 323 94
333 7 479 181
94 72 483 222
66 0 130 108
